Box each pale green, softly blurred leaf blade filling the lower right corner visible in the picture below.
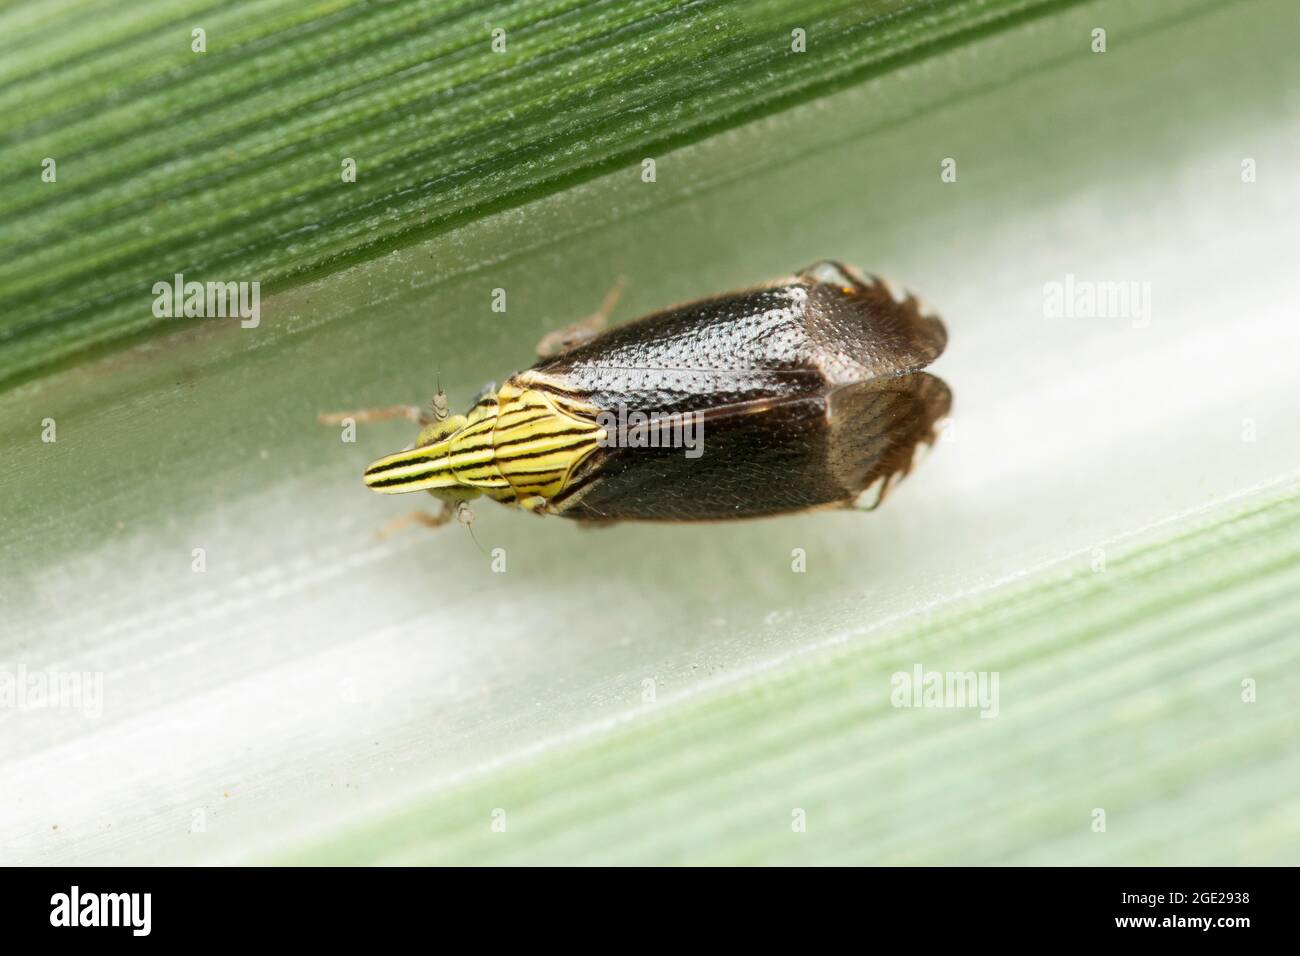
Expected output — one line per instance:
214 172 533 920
278 484 1300 865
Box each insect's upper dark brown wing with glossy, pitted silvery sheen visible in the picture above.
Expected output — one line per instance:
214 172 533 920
520 261 946 421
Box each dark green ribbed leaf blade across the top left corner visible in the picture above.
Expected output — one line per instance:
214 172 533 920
0 0 1065 385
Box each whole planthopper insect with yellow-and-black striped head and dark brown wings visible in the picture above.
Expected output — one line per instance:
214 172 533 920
322 261 950 524
